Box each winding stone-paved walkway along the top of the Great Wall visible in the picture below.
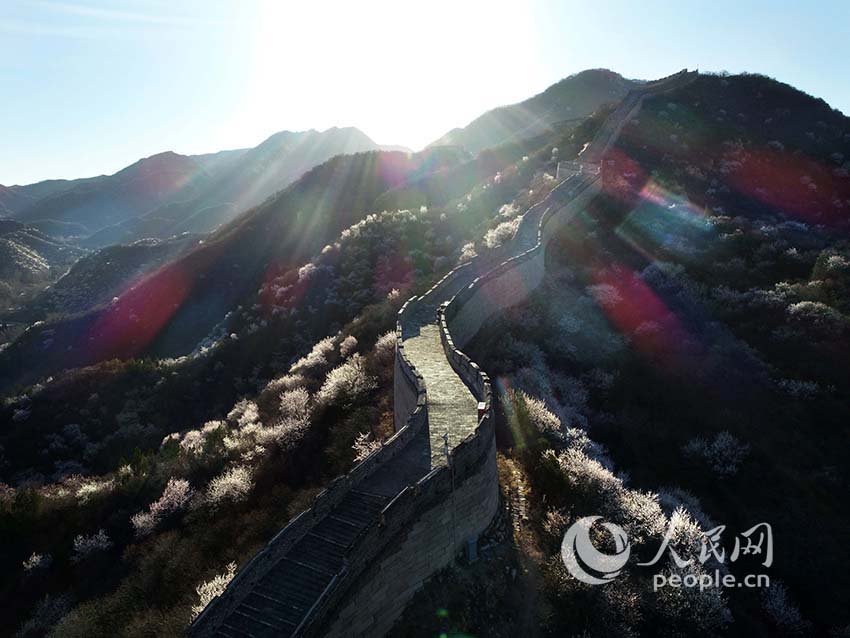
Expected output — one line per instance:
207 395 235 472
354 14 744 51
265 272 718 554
189 69 693 638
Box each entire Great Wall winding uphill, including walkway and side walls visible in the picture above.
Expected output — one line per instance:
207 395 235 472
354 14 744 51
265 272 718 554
188 70 696 638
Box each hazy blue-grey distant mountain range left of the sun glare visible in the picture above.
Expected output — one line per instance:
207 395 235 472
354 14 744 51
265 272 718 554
0 128 390 248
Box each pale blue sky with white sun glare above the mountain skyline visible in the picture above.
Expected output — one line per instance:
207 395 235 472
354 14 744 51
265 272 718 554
0 0 850 185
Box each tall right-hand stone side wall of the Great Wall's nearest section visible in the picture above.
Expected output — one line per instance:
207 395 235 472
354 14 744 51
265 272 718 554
321 278 499 638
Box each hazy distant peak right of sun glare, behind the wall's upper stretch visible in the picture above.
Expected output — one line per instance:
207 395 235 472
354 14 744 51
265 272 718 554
429 69 638 155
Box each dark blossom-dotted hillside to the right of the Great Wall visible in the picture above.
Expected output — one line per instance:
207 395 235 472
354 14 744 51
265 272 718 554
458 75 850 636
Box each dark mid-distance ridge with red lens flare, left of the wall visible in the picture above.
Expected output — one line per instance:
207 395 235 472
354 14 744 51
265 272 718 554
0 148 469 387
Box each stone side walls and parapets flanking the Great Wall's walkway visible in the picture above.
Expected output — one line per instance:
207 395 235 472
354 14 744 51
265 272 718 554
189 73 695 637
